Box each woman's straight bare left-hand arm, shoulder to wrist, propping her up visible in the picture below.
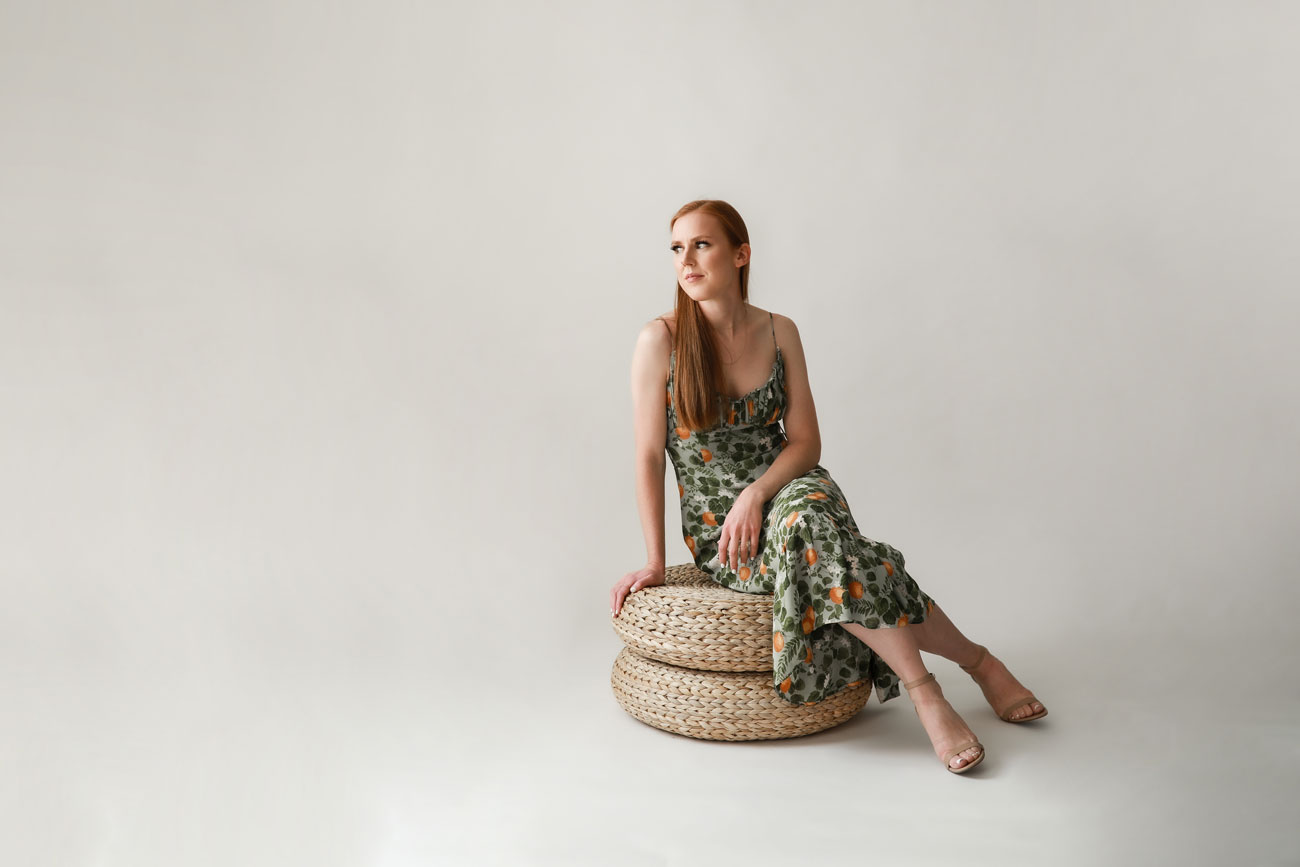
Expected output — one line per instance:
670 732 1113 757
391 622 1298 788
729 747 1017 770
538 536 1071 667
632 318 672 568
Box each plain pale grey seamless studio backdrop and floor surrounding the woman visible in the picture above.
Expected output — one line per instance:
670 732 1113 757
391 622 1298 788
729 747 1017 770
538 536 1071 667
0 0 1300 867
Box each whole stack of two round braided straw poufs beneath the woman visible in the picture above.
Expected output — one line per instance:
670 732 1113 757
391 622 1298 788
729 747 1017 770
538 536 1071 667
610 563 871 741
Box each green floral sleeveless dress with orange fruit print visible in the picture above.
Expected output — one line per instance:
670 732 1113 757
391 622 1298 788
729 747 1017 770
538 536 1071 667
667 315 933 705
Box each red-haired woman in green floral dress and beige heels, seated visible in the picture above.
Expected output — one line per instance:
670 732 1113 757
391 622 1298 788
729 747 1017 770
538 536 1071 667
610 200 1047 773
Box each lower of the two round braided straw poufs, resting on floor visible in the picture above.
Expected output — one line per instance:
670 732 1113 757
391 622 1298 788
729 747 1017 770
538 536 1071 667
610 647 871 741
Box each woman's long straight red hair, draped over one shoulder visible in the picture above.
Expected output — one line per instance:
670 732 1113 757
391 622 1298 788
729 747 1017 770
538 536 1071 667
668 199 749 430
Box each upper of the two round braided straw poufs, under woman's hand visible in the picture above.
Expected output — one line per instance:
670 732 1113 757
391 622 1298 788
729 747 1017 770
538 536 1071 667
611 563 772 672
